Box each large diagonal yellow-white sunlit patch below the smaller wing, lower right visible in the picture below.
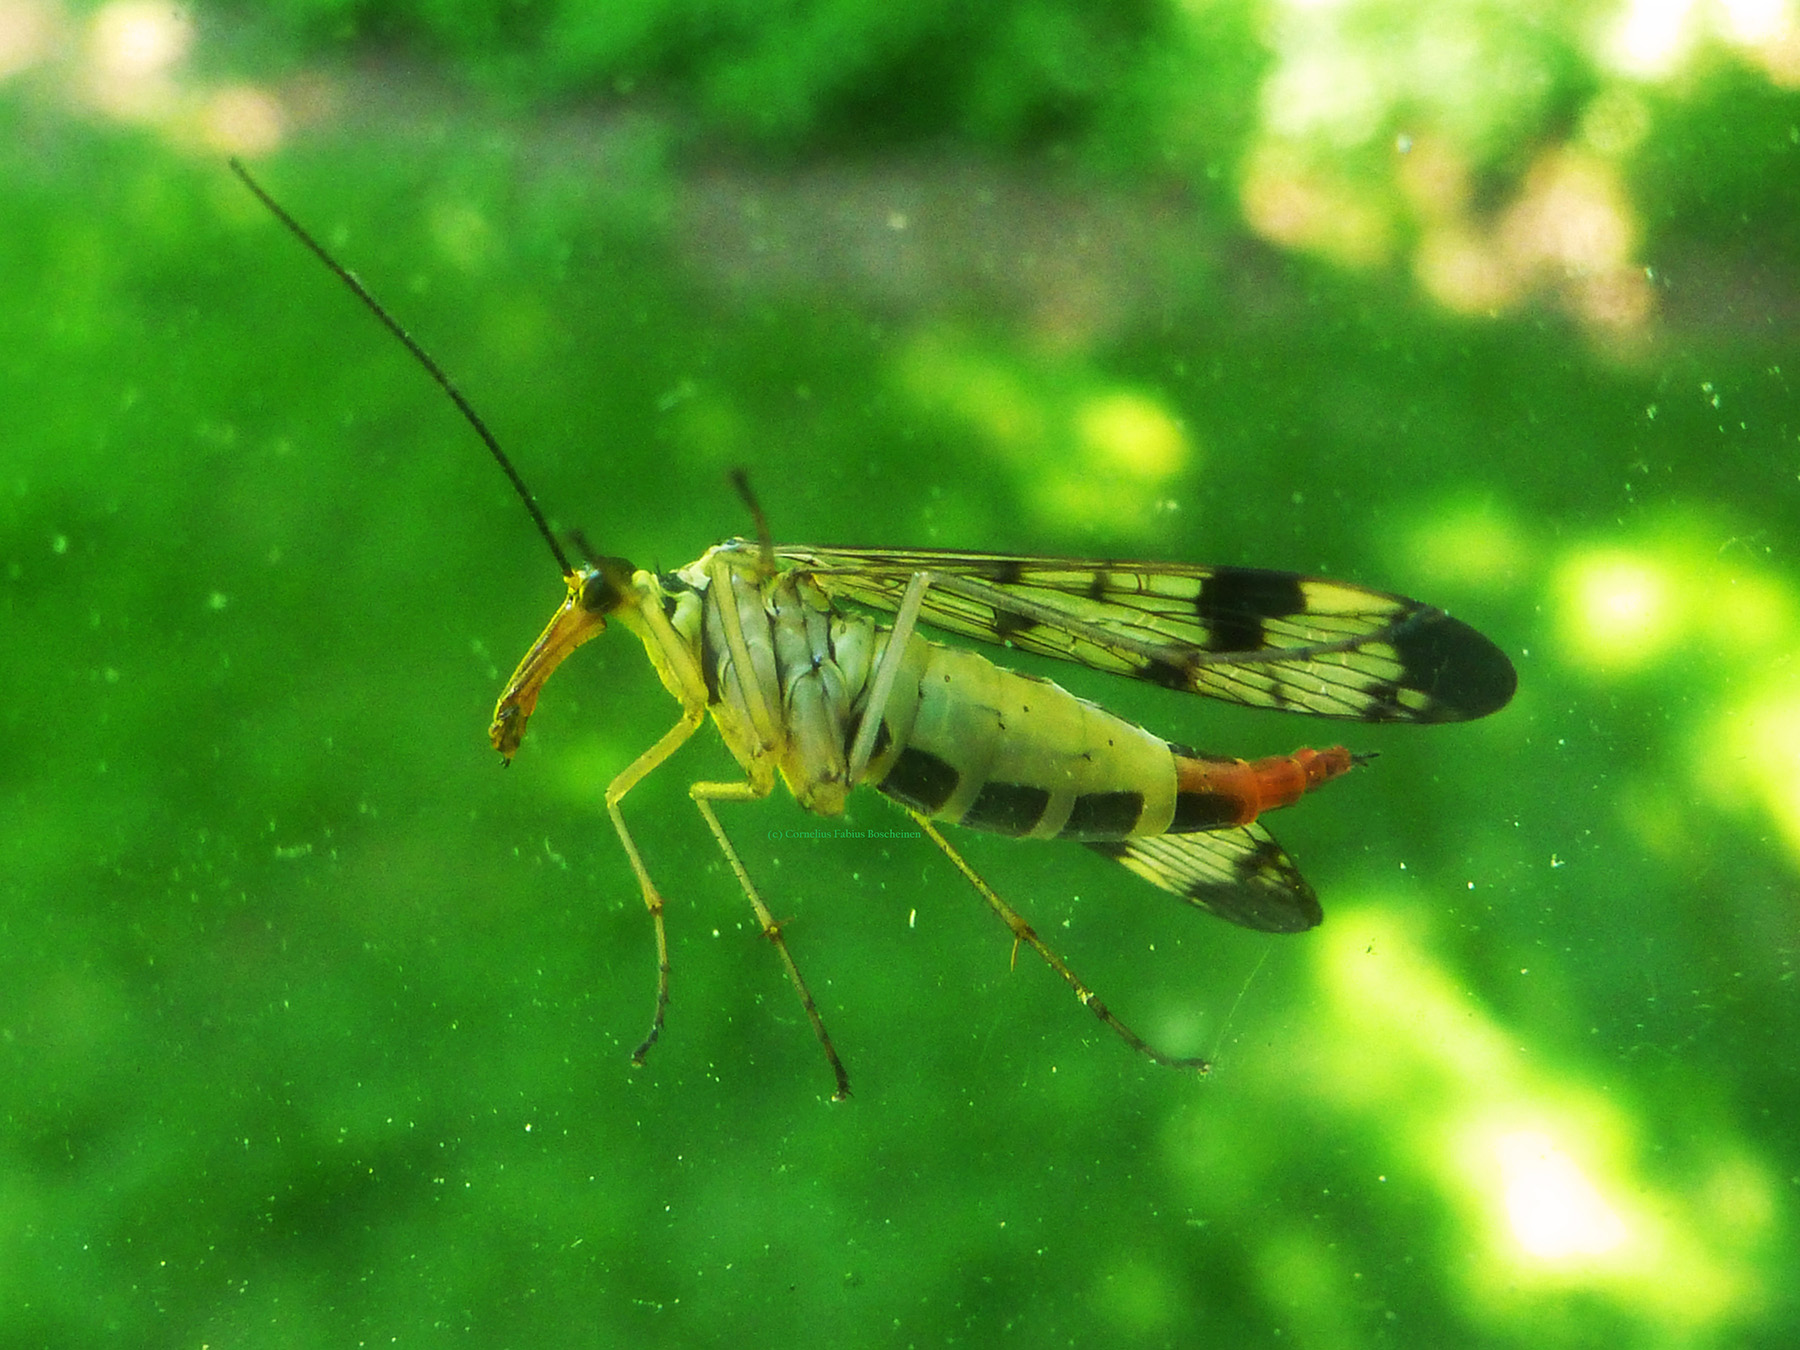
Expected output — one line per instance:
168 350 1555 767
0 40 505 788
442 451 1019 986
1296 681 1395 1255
1300 907 1775 1336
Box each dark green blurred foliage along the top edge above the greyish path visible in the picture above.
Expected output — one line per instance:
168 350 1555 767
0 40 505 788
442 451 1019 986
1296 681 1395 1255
221 0 1262 171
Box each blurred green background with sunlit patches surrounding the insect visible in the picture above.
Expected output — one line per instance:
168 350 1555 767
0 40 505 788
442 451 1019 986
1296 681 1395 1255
0 0 1800 1348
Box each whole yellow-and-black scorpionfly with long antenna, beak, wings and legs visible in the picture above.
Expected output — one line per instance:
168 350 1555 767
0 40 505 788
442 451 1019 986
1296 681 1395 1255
232 164 1516 1096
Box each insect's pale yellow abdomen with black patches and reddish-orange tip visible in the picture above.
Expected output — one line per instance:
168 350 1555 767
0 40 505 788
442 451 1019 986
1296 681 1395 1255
868 639 1352 841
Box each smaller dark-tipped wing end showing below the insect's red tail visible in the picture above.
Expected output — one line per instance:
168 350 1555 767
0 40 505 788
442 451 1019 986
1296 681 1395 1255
1089 824 1325 932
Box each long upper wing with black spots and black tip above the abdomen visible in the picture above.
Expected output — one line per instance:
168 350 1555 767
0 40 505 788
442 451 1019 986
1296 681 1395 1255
776 547 1517 722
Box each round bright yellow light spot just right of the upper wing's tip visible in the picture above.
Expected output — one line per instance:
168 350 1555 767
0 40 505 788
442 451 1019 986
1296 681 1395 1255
1553 549 1683 670
